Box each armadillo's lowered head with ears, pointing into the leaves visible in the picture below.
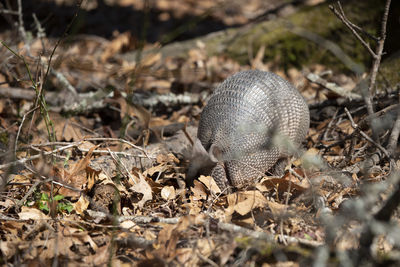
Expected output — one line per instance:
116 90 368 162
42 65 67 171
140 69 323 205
186 138 222 185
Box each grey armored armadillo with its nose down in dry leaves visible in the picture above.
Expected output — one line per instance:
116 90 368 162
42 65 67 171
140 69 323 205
187 70 310 190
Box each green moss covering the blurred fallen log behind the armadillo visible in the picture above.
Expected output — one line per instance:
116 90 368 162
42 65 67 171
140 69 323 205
225 0 383 73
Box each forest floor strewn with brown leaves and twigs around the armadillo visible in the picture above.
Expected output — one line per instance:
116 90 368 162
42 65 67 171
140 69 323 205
0 0 400 266
